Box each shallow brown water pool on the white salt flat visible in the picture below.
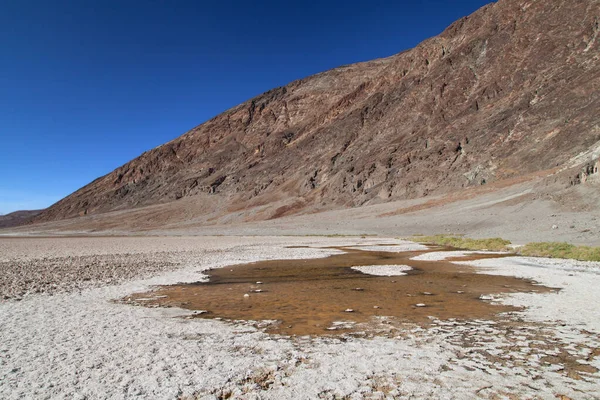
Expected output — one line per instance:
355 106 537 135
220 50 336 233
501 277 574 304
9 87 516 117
123 248 551 335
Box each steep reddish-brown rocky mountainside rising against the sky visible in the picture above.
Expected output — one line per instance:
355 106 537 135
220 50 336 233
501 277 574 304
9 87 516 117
35 0 600 222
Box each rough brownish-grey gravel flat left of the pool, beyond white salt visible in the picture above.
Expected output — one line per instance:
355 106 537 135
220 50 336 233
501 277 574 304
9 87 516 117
0 237 342 300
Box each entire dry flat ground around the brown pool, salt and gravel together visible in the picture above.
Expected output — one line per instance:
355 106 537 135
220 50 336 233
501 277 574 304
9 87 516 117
0 236 600 399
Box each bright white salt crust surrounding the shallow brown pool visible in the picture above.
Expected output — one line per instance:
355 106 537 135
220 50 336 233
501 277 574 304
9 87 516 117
0 237 600 400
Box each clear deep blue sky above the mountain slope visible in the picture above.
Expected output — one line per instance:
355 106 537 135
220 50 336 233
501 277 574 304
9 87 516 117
0 0 488 213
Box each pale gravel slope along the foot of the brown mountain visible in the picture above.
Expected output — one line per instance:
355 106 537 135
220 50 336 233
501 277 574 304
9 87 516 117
5 182 600 245
